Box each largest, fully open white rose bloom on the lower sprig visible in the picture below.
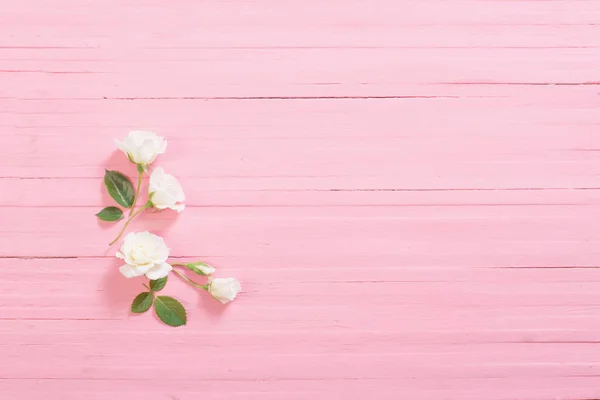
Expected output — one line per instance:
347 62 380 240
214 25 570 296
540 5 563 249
117 232 173 279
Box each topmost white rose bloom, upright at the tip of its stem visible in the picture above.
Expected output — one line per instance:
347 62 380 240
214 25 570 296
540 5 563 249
115 131 167 166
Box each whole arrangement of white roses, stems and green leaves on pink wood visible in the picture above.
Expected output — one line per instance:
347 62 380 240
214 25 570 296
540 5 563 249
96 131 242 326
